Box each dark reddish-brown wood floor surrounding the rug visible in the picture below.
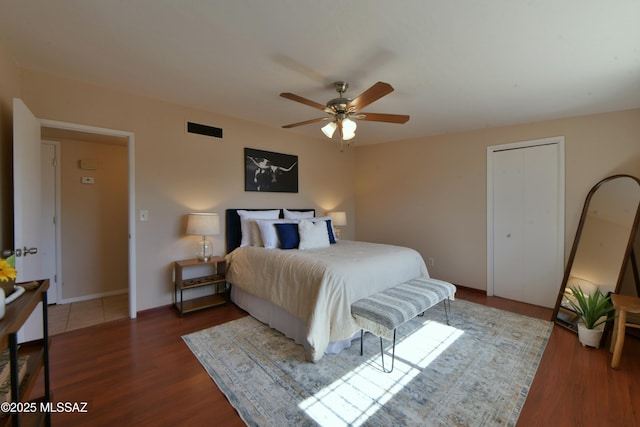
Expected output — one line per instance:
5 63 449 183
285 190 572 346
36 289 640 427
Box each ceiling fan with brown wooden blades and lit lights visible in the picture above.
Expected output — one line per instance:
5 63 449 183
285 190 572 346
280 81 409 148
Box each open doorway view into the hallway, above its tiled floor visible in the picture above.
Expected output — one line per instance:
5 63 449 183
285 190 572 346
41 135 128 306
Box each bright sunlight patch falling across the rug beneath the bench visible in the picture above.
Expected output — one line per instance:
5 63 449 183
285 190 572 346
299 320 464 426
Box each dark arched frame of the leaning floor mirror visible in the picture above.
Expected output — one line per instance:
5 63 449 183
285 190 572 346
551 174 640 333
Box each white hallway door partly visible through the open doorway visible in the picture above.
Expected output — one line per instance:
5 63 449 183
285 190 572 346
40 141 59 304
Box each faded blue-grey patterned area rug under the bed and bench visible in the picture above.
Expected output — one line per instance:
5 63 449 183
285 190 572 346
183 300 552 427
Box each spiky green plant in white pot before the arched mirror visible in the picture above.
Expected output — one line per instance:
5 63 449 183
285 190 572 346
569 287 614 348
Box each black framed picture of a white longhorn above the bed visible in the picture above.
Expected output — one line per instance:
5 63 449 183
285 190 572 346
244 148 298 193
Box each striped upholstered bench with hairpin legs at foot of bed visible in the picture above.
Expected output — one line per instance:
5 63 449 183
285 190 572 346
351 277 456 372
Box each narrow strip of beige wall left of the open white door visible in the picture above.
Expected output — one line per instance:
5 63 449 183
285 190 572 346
0 43 20 250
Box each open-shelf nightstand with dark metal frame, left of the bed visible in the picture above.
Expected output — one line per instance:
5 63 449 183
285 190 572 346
173 256 227 316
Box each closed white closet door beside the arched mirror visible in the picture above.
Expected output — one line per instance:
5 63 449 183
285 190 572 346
487 139 564 307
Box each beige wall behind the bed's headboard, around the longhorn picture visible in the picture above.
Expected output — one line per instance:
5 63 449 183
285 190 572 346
21 70 354 310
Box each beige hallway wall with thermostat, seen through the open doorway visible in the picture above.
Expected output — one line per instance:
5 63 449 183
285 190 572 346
58 140 129 300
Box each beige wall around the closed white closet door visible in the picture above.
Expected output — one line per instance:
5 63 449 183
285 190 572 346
355 110 640 290
